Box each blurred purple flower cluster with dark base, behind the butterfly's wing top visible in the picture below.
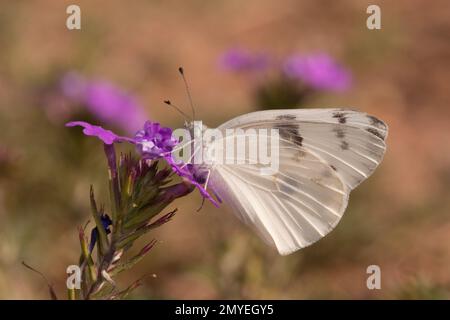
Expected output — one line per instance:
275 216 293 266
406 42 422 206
220 48 352 109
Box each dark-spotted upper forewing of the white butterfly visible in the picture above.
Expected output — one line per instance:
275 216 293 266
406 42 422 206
219 109 388 189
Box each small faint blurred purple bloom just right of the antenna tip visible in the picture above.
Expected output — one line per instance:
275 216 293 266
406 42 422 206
220 49 268 71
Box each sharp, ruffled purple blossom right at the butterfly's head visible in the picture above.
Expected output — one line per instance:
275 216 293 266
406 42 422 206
134 121 178 159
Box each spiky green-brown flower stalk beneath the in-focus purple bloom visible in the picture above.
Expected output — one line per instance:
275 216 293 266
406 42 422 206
72 151 194 300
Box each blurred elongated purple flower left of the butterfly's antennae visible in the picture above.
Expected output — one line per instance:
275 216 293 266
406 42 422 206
61 72 146 133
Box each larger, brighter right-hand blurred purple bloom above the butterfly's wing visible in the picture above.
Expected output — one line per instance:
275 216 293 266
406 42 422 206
283 54 351 91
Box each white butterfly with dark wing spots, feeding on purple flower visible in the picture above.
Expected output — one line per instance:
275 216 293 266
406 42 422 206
185 109 388 255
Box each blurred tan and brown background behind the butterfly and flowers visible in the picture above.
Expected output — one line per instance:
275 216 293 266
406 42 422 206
0 0 450 299
